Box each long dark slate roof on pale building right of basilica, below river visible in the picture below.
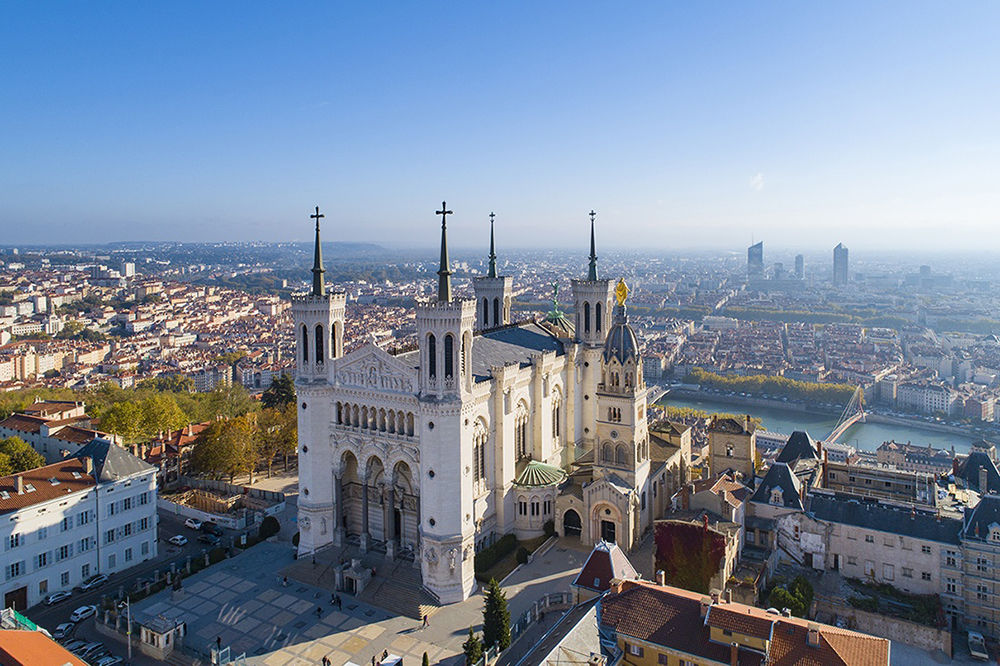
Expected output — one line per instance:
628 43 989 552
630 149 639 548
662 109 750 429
806 491 962 545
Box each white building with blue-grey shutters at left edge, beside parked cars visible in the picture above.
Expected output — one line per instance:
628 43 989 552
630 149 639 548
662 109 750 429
0 440 157 610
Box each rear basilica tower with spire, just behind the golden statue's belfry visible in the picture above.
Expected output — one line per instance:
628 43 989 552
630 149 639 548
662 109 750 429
572 211 612 450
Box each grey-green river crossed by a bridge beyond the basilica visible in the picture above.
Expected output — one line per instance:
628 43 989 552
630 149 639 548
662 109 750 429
660 395 979 453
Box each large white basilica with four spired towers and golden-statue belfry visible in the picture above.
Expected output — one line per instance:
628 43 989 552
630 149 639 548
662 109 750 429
292 204 690 603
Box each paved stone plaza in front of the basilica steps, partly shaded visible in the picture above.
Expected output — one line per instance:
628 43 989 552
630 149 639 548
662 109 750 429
133 541 589 666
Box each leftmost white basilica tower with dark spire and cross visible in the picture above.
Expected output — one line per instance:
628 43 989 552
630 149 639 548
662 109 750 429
292 206 347 554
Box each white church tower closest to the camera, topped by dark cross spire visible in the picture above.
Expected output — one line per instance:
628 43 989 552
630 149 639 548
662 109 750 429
416 202 476 603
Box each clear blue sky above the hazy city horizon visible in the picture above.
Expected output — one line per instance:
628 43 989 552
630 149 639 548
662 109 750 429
0 0 1000 249
